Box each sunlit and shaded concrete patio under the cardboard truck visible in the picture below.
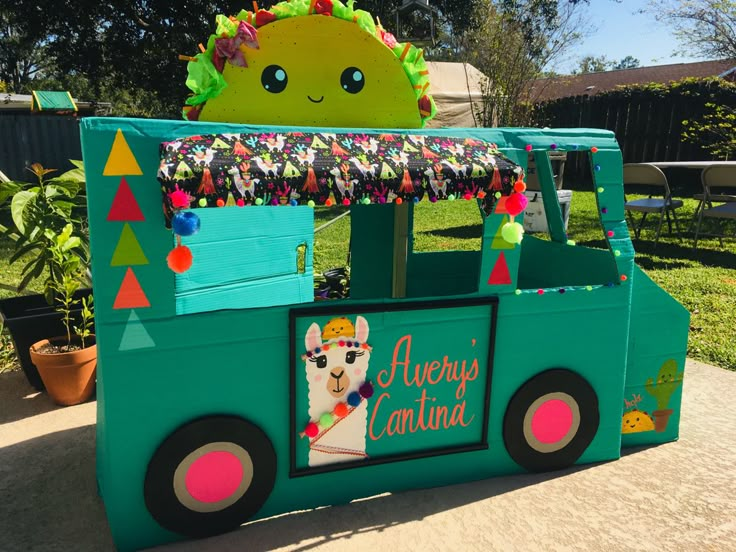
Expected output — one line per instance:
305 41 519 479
0 361 736 552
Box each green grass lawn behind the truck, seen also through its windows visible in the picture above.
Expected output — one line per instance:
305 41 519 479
0 191 736 371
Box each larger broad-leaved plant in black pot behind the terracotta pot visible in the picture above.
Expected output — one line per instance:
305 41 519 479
0 161 91 391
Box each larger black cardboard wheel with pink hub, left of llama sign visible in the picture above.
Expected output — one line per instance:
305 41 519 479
143 416 276 537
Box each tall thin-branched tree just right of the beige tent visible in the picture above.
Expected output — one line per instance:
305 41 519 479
461 0 589 126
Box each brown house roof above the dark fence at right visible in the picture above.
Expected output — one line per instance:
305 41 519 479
529 59 736 102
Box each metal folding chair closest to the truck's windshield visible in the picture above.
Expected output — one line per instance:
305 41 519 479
624 163 683 247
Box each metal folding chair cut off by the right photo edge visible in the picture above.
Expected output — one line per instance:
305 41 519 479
693 165 736 249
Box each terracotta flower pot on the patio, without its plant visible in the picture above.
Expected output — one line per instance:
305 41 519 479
30 335 97 406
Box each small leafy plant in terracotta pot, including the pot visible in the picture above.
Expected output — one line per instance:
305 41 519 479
29 224 97 405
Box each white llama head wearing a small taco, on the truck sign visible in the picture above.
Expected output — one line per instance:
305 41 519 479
303 316 371 402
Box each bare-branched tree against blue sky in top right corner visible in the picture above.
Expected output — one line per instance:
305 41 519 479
648 0 736 59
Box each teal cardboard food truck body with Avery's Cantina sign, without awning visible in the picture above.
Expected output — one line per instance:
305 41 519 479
81 118 688 550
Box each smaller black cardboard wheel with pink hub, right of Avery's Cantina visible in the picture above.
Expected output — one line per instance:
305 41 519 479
503 368 600 471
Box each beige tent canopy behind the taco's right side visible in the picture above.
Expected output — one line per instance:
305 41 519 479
427 61 487 128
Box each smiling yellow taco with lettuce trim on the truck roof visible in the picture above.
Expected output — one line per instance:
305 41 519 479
183 0 436 128
